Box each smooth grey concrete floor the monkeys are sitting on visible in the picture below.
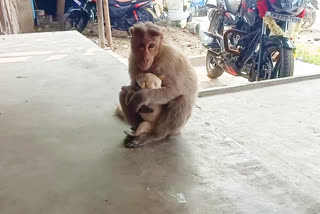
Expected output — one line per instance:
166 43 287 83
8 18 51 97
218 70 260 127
0 32 320 214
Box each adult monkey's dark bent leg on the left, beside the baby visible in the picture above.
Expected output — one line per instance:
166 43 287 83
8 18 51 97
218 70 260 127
119 91 141 129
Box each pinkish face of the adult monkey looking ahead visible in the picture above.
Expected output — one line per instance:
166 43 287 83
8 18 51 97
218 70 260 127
132 35 161 72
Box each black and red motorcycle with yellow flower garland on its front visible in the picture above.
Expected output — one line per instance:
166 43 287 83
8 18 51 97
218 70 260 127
204 0 305 82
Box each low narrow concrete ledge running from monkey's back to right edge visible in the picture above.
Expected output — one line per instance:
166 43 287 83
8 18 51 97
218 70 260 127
199 74 320 97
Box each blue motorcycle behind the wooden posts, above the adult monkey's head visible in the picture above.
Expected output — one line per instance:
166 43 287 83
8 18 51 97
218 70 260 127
63 0 154 32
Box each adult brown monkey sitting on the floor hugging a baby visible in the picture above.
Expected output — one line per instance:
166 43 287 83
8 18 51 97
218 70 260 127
120 22 198 148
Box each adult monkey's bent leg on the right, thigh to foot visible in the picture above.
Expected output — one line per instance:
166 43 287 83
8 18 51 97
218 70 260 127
125 95 192 148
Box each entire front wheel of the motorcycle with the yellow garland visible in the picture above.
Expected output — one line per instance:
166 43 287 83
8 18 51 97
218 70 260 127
260 46 294 79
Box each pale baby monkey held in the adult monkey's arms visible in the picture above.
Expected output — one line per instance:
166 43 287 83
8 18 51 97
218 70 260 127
125 73 163 136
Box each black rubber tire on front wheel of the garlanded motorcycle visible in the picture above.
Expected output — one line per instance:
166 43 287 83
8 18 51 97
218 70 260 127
264 46 294 79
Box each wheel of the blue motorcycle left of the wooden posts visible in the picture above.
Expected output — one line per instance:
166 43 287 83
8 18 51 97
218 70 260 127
63 12 88 33
